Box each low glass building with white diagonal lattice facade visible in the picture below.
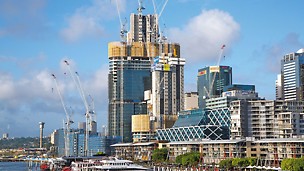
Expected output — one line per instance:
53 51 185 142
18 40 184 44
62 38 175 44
157 108 231 142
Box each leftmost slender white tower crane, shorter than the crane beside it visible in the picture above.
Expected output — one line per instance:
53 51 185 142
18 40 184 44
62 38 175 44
52 74 74 156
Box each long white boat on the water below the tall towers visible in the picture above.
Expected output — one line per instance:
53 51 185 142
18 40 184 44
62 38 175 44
71 157 148 171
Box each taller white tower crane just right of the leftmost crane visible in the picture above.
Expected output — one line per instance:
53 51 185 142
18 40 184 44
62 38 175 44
64 60 95 156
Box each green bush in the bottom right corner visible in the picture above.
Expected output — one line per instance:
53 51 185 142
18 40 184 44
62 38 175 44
281 158 304 171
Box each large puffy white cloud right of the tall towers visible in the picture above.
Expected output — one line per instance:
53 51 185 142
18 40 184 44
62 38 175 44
169 9 240 63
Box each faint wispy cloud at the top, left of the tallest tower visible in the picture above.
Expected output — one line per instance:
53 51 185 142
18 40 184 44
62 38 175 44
60 0 126 42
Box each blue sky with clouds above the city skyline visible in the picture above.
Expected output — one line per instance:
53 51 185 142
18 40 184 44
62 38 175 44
0 0 304 137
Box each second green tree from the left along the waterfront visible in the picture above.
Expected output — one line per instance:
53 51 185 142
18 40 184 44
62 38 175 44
175 152 200 166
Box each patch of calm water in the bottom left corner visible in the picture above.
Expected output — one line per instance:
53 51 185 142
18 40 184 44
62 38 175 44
0 162 40 171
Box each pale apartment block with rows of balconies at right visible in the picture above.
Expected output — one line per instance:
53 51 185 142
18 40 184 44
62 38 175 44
230 100 304 140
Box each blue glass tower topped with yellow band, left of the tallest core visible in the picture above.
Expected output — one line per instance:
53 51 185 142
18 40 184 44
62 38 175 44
108 42 151 142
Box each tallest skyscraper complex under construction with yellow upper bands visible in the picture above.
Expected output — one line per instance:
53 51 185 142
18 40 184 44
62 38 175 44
108 3 184 142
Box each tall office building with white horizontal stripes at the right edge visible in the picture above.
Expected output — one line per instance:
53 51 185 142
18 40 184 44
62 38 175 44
281 48 304 100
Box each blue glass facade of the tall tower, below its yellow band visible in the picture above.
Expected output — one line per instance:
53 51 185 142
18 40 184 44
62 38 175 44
108 57 152 142
